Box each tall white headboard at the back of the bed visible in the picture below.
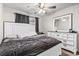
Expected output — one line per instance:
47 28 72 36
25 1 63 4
3 22 35 38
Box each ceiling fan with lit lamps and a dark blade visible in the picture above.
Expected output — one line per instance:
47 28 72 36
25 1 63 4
37 3 56 14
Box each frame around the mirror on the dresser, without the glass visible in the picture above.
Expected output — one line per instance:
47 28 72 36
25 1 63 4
53 13 73 32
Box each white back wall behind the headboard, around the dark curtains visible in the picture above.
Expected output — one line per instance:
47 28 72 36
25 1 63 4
3 7 42 32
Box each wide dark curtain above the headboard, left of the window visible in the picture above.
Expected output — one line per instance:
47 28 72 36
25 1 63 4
15 13 29 24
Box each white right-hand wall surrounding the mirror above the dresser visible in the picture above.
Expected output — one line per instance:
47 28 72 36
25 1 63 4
42 4 79 32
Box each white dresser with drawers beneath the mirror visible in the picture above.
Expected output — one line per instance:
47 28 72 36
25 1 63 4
47 31 77 54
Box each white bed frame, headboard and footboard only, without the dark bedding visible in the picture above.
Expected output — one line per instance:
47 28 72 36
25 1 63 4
3 22 61 56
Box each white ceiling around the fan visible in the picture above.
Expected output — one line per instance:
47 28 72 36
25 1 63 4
3 3 77 16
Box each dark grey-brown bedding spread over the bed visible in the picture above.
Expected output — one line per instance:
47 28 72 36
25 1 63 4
0 35 61 56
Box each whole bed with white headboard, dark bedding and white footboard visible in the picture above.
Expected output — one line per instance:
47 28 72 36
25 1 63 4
0 22 61 56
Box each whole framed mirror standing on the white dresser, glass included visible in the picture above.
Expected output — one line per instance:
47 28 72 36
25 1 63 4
53 14 72 32
